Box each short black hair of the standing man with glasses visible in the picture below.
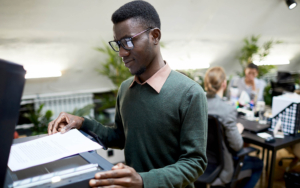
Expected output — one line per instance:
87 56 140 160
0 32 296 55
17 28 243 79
111 1 160 29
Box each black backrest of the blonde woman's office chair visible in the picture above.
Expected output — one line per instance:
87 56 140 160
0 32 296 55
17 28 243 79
206 115 224 169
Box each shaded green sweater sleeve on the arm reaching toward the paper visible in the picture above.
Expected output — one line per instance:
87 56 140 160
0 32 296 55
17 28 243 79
81 90 125 149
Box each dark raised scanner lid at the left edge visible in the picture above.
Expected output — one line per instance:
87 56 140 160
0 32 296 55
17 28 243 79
0 59 26 187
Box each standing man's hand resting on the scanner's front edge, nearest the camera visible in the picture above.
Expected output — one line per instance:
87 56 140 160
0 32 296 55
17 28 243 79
89 163 143 188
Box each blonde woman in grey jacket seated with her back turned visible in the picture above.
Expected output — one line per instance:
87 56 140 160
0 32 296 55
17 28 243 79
204 67 263 188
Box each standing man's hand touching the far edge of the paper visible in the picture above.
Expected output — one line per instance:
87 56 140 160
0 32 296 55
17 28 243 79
48 112 84 135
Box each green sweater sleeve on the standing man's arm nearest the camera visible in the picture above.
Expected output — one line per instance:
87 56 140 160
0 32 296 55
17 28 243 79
140 84 207 188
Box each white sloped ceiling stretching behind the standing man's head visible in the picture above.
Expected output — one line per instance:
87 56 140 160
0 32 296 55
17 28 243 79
0 0 300 97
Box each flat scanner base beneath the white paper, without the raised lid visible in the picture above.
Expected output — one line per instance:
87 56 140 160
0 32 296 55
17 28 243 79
5 130 113 188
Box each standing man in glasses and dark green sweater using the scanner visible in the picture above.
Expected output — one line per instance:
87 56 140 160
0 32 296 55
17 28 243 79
48 1 207 188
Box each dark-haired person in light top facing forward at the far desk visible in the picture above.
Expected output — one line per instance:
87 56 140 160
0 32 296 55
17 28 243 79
227 63 266 102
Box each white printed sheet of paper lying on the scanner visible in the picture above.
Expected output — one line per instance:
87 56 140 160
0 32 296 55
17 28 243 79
8 129 102 171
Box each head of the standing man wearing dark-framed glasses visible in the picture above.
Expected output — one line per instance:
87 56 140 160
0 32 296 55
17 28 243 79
111 1 161 75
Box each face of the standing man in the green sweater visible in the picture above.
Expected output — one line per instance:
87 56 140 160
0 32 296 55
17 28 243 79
113 19 154 75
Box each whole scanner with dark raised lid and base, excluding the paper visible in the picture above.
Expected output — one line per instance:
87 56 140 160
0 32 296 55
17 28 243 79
0 59 113 188
